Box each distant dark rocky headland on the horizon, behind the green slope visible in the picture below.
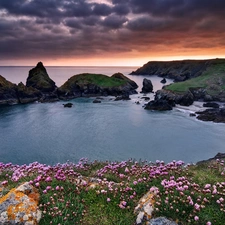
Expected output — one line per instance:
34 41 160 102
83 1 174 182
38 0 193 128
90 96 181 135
131 59 216 82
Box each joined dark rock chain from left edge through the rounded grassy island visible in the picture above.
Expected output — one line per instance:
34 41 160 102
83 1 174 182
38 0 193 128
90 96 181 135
0 62 138 105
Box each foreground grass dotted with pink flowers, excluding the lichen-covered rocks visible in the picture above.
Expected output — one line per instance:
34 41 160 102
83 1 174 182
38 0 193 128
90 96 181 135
0 159 225 225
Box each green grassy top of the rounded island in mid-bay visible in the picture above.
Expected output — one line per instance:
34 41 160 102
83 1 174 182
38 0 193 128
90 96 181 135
59 73 126 87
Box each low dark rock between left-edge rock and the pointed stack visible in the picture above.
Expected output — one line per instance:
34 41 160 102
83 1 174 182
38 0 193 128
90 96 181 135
17 82 42 104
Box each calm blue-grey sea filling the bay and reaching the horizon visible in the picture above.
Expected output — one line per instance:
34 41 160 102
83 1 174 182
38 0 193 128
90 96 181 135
0 66 225 165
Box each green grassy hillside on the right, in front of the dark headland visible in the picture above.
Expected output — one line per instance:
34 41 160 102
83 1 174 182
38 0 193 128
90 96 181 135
166 61 225 95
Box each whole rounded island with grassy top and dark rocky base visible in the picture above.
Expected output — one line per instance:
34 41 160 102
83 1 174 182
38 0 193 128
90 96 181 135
58 74 137 99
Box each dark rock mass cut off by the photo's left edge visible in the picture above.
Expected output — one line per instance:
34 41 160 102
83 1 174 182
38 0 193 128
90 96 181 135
0 75 19 105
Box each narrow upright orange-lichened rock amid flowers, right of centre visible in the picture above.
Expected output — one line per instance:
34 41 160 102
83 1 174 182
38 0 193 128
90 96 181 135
134 187 158 225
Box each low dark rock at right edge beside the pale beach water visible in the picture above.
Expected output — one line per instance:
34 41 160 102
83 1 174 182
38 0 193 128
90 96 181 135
196 108 225 123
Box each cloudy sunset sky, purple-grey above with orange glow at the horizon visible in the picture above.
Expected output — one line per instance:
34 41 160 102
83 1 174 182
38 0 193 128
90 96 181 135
0 0 225 66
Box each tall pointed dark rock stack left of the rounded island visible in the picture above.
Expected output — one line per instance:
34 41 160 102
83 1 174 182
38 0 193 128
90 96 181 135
26 62 56 93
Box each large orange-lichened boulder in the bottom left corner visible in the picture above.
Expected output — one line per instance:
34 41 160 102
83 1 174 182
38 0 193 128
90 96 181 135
0 182 41 225
